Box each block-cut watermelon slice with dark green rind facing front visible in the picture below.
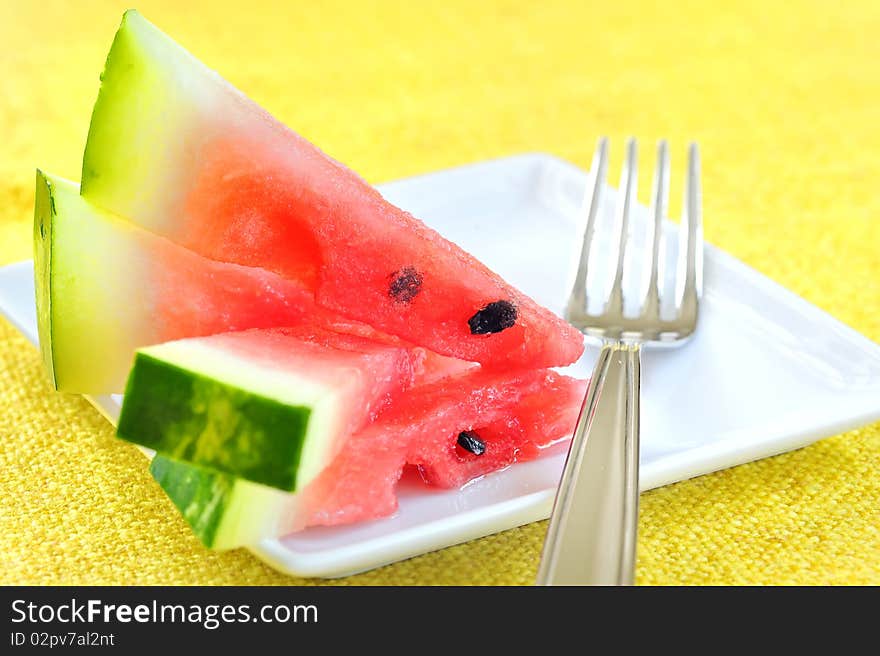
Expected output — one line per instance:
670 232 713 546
117 328 423 491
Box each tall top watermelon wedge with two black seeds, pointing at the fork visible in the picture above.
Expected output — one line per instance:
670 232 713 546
82 11 583 368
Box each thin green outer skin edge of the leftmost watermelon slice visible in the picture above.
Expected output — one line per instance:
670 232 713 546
34 169 58 389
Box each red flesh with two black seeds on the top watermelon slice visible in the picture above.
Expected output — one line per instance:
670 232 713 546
184 132 583 368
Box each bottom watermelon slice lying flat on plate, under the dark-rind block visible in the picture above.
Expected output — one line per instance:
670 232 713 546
150 371 584 549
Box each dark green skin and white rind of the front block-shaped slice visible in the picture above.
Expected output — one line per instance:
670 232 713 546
117 342 335 492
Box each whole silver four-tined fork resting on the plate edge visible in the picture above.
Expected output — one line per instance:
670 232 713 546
538 138 703 585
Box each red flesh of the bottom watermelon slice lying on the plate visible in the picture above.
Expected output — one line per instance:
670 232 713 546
292 370 585 532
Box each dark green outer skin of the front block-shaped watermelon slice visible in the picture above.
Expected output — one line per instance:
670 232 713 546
117 352 312 491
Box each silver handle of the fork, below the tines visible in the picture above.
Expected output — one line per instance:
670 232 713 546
537 343 640 585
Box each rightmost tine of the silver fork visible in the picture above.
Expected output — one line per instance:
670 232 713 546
676 143 703 321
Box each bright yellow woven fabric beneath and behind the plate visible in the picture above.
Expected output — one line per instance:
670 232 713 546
0 0 880 584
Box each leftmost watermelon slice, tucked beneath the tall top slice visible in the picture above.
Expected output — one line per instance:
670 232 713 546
34 171 356 394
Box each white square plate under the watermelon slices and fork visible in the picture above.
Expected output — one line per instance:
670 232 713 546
0 154 880 577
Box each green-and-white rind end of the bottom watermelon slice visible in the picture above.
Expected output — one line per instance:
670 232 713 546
150 454 292 549
